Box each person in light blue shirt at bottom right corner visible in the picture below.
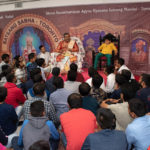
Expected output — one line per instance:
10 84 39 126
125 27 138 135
125 98 150 150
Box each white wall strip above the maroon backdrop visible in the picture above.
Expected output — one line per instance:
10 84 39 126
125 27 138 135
0 0 150 11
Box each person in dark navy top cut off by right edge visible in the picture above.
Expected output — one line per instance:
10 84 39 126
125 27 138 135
136 74 150 111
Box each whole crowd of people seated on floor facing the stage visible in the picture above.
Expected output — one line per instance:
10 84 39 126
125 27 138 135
0 46 150 150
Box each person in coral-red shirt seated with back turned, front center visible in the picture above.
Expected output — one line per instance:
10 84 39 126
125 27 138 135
60 93 97 150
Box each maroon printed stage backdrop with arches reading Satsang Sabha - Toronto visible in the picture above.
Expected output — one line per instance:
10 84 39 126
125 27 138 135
0 3 150 74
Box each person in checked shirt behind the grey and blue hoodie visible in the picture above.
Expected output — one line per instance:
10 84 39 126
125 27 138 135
23 83 58 124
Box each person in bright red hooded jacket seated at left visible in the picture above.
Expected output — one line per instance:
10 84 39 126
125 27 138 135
4 73 26 119
